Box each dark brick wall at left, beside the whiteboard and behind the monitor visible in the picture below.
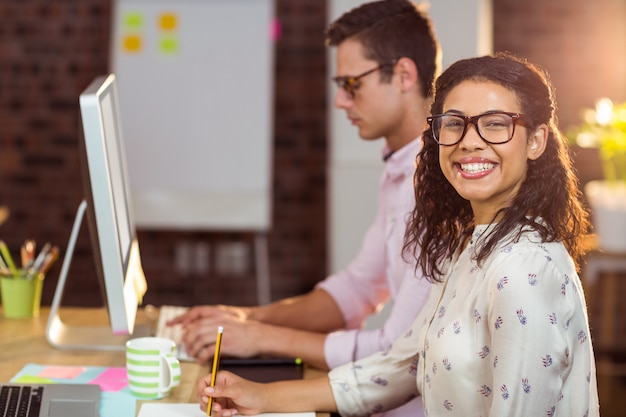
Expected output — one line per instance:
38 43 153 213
0 1 115 303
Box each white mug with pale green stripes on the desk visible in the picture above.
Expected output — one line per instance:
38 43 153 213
126 337 180 399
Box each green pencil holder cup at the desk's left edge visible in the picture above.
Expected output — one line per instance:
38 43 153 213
0 273 44 319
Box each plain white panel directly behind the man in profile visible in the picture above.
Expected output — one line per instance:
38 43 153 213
328 0 492 282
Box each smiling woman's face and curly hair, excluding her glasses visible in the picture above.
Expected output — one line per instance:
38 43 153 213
411 54 589 273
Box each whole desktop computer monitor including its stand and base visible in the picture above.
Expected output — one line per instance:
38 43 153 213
46 74 147 350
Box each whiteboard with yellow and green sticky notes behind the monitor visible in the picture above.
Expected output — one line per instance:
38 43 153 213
111 0 274 231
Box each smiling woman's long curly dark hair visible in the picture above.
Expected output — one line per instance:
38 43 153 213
404 53 589 281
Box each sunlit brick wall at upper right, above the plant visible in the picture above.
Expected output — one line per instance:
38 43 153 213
493 0 626 132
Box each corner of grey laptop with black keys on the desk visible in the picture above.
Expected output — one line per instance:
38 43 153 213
0 383 100 417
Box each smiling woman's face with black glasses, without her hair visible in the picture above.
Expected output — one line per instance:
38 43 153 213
430 80 547 224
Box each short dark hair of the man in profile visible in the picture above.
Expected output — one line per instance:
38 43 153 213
325 0 441 97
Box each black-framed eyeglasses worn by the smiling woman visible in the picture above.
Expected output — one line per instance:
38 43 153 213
426 111 525 146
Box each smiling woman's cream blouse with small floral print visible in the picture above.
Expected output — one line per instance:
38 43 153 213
329 225 599 417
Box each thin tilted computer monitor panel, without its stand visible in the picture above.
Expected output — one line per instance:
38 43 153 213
80 74 145 334
